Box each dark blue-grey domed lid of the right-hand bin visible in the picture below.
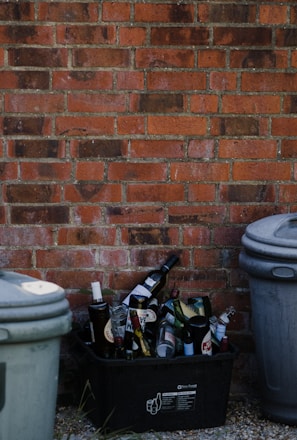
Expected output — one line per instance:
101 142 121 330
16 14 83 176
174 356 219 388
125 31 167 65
242 213 297 262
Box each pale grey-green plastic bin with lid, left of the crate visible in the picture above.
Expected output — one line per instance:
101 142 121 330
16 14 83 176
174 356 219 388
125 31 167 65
0 271 71 440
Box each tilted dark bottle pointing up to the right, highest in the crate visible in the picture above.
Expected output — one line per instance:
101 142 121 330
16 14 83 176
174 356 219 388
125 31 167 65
123 255 179 305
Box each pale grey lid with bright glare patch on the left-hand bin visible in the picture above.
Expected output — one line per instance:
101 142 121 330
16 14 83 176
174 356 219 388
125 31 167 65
0 271 69 323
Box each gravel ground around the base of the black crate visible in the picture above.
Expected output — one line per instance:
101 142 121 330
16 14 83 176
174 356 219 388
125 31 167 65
54 397 297 440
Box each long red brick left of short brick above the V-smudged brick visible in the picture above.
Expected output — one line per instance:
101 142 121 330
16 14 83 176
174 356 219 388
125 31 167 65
20 162 72 181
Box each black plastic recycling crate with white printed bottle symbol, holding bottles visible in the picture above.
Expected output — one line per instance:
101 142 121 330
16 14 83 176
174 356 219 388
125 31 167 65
71 332 237 432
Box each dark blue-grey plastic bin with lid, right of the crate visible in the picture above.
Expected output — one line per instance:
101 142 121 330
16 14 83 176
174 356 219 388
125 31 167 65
239 213 297 425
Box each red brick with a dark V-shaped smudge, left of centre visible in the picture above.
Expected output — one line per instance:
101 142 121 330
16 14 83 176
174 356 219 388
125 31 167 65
65 181 122 203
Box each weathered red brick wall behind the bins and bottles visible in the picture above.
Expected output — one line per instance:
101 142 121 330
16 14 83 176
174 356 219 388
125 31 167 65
0 0 297 352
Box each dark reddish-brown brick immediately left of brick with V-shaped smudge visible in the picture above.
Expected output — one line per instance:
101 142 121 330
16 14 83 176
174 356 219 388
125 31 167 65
5 183 61 203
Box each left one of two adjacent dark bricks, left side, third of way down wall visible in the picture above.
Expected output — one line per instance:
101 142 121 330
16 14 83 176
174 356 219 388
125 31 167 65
8 139 65 158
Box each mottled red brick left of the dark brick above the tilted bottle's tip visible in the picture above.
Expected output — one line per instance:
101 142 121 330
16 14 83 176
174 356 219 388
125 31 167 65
58 226 116 246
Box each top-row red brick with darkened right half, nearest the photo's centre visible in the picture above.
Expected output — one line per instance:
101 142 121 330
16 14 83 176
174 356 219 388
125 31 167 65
135 3 194 23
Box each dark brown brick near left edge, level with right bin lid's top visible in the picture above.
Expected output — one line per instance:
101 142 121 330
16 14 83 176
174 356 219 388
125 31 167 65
10 207 69 225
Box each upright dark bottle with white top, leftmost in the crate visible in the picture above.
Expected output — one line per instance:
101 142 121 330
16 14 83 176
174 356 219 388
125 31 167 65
88 282 113 358
